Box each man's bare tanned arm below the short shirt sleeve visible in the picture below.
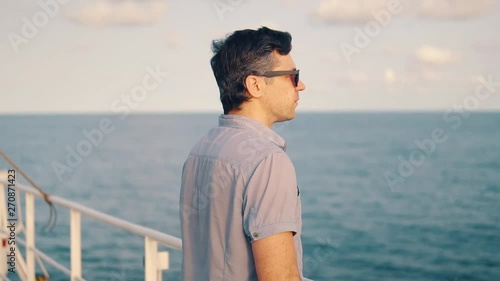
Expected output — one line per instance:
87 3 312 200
252 232 300 281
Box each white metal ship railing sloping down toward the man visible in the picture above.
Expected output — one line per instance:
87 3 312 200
0 175 182 281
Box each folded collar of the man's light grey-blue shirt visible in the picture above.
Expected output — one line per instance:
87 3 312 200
219 114 286 151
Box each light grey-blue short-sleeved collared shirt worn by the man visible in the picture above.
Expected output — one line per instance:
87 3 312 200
179 115 309 281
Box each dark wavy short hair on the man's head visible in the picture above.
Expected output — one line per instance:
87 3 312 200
210 27 292 114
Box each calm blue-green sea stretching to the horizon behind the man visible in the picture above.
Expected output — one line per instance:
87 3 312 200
0 112 500 281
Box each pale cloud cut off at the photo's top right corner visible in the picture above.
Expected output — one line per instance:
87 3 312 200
417 0 497 19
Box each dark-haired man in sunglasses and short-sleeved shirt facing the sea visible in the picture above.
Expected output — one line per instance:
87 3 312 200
179 27 308 281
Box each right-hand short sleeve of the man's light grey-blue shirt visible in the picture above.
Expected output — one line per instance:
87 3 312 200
243 152 301 242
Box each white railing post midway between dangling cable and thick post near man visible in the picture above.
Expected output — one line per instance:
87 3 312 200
70 209 82 281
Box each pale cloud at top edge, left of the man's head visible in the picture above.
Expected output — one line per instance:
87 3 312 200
68 0 167 25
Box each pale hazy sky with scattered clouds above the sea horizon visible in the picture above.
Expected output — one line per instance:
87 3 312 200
0 0 500 114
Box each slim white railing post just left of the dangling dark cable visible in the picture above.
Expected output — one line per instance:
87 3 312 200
26 192 35 281
